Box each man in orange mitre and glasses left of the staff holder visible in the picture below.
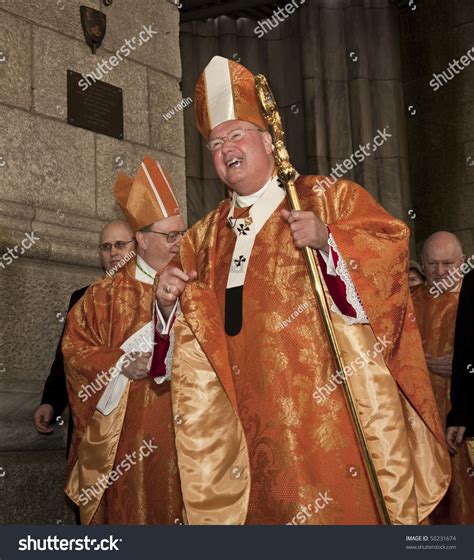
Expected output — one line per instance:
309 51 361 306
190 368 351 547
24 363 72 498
62 157 185 525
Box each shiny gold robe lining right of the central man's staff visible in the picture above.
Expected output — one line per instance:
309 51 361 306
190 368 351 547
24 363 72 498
332 304 450 525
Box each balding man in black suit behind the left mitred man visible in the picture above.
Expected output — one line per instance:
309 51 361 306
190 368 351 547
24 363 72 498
34 220 135 442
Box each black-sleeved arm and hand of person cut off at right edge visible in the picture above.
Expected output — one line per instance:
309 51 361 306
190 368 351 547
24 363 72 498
446 271 474 453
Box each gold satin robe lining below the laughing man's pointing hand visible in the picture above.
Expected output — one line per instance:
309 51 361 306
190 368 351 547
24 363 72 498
172 315 250 525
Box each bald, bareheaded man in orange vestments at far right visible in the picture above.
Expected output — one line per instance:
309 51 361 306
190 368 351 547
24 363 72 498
413 232 474 524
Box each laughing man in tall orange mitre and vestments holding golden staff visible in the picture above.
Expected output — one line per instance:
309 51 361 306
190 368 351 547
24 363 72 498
156 57 450 524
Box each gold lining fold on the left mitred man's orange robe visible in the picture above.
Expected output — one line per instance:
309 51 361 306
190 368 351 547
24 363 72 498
65 383 130 525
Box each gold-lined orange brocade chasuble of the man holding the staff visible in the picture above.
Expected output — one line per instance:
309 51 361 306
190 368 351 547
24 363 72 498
172 176 450 524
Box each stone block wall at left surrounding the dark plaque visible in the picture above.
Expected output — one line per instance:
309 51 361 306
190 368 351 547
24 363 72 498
0 0 186 524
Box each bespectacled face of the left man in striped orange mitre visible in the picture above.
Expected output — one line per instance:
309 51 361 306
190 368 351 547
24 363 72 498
136 216 186 270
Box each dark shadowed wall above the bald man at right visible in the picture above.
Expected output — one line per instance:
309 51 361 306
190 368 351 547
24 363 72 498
400 0 474 255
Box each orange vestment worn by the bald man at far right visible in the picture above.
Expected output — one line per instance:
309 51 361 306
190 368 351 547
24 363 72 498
413 284 474 524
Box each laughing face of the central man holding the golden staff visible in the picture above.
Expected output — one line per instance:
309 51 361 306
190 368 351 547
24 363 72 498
209 120 275 196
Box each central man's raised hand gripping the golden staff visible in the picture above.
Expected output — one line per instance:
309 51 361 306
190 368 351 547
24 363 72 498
281 209 329 253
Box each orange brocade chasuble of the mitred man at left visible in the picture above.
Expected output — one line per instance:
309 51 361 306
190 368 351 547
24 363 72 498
62 261 182 524
